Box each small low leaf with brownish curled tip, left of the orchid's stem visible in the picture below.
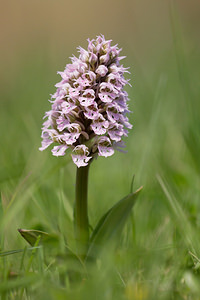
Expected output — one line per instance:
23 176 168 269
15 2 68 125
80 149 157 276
18 229 58 246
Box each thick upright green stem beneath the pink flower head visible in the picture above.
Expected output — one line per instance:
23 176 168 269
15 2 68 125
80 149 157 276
74 165 89 260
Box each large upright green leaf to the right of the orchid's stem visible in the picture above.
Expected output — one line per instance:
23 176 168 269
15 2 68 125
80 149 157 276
86 187 142 260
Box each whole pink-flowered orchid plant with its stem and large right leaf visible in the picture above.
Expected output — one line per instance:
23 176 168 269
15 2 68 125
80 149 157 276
39 35 142 261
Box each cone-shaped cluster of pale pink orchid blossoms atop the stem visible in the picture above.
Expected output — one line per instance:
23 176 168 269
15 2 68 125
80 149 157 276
40 36 132 167
